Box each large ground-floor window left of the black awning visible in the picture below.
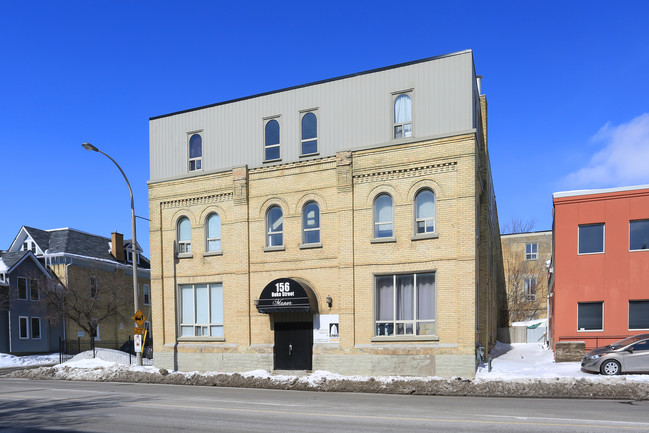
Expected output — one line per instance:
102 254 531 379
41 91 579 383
180 283 224 338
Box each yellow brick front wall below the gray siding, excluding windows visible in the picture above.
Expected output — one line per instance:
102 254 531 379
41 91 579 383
149 134 502 371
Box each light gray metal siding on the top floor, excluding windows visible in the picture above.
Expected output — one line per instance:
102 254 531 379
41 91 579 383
149 51 475 181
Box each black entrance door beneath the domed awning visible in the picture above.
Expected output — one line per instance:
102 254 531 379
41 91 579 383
275 322 313 370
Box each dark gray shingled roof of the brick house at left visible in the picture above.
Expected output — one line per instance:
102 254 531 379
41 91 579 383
25 227 150 269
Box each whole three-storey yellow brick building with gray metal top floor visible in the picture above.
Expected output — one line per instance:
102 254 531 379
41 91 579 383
149 51 504 377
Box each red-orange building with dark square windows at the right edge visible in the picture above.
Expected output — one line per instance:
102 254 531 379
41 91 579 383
550 185 649 349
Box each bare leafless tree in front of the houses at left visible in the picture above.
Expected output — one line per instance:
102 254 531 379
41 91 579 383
43 267 132 337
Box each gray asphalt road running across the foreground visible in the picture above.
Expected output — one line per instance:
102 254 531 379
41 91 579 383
0 378 649 433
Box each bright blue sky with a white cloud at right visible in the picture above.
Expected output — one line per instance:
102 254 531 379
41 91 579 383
0 0 649 254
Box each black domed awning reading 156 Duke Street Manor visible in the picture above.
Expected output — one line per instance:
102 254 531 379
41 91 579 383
257 278 317 313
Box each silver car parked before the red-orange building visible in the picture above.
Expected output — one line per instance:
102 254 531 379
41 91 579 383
581 334 649 376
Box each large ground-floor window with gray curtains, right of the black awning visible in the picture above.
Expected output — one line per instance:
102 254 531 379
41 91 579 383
374 272 437 336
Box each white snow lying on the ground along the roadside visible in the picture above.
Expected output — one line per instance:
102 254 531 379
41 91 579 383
0 343 649 383
